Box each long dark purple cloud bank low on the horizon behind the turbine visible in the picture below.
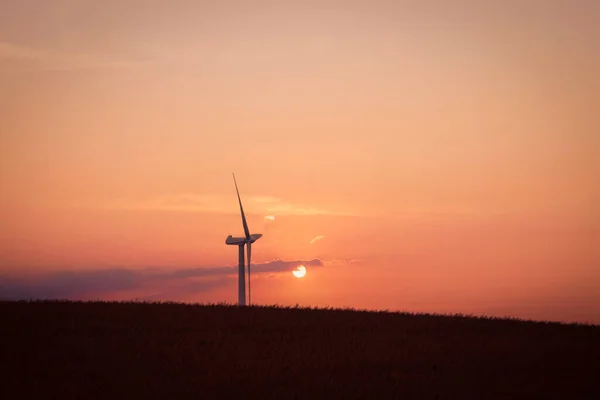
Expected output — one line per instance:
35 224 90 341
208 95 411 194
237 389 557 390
0 259 324 300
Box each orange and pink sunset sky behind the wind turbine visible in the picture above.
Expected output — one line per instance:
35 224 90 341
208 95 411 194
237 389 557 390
0 0 600 323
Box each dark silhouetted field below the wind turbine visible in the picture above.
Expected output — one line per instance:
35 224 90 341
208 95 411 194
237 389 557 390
0 301 600 399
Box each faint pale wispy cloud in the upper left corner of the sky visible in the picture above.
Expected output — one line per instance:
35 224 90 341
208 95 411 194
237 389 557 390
0 42 142 71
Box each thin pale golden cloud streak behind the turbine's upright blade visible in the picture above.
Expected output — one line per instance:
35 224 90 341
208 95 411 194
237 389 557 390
93 193 356 220
